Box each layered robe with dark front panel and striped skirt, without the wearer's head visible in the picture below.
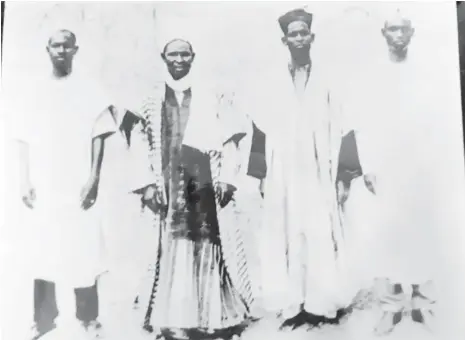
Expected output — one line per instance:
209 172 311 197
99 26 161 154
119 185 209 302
130 77 251 331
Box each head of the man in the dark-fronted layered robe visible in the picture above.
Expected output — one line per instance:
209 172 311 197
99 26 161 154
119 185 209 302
161 39 195 80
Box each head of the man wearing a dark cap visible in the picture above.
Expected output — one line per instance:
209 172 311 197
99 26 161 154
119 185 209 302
278 9 315 56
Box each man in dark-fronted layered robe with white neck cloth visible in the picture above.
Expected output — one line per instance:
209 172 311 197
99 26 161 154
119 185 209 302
118 37 253 339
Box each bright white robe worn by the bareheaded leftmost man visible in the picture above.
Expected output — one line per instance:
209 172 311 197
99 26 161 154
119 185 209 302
6 72 115 288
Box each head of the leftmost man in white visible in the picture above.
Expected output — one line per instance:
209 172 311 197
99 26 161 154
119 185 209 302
47 29 79 74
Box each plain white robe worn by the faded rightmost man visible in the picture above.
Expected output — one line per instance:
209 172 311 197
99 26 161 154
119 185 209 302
347 51 443 285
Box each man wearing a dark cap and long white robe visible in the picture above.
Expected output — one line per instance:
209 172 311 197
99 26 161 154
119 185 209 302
252 9 362 328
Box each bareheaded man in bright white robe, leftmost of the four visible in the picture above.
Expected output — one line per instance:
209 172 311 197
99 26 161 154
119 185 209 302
7 30 115 337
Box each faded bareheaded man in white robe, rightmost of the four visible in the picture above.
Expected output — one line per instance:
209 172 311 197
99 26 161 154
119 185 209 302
348 11 439 333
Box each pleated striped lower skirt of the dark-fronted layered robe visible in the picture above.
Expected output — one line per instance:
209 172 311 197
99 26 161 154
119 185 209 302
150 232 247 330
